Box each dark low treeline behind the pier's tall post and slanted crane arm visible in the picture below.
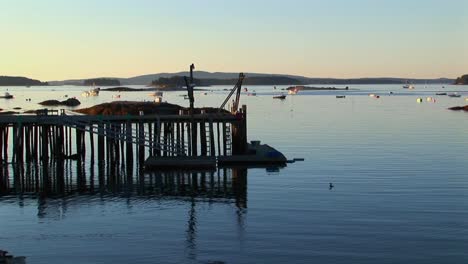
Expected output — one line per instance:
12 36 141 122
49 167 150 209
151 76 302 87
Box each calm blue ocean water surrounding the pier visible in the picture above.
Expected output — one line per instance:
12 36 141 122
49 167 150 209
0 85 468 264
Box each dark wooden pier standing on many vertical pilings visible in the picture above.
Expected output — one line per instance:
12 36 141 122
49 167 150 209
0 105 247 165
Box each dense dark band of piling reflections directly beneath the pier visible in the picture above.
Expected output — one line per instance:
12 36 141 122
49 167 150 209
0 161 247 209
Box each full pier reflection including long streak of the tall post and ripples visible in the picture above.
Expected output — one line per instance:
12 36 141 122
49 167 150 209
0 161 247 263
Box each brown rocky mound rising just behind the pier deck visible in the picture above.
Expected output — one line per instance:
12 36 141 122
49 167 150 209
75 101 226 115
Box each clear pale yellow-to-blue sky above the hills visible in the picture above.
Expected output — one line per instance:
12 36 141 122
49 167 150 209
0 0 468 81
